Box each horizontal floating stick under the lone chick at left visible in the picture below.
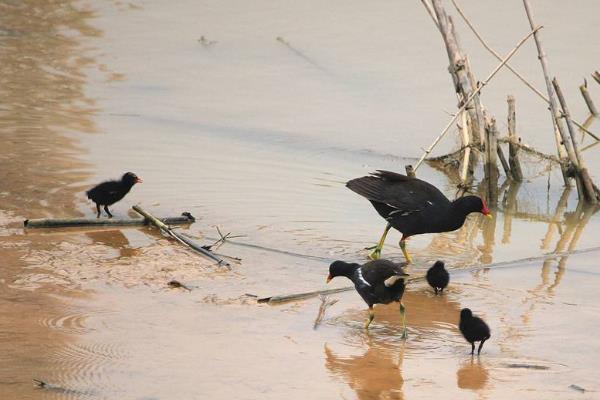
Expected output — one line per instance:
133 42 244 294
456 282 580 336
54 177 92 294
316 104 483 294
23 212 196 228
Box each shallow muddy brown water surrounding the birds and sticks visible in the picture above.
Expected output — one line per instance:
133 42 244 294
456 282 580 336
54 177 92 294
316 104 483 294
0 1 600 399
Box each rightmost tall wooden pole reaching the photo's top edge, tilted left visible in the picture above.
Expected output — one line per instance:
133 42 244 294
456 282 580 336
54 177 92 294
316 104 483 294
523 0 575 185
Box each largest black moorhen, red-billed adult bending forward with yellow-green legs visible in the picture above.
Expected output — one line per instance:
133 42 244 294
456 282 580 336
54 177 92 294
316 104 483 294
346 170 491 262
